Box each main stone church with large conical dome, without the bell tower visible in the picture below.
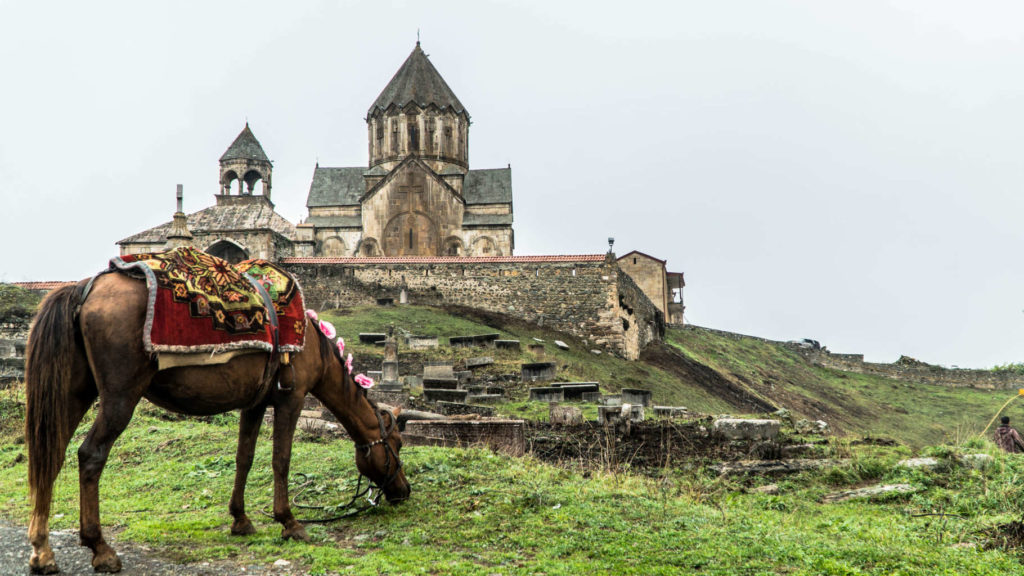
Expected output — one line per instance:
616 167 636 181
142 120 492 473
296 42 515 257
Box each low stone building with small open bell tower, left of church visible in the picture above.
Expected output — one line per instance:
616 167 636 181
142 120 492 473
118 123 295 262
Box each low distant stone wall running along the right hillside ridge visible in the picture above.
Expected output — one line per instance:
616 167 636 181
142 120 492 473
685 325 1024 389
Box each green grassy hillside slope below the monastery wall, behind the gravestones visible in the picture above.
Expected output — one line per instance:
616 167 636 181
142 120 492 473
326 306 1014 447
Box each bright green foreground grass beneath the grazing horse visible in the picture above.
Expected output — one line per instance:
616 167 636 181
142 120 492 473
0 383 1024 575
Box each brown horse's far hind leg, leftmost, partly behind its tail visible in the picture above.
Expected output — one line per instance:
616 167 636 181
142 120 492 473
29 366 96 574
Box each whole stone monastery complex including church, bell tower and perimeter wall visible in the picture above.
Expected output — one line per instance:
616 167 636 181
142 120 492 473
105 42 684 359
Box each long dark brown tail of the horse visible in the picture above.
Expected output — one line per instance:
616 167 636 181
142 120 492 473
25 286 81 500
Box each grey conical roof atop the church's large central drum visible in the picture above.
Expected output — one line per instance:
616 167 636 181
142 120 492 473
367 42 468 117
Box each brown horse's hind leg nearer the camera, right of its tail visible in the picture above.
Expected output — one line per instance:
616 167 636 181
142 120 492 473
78 387 141 572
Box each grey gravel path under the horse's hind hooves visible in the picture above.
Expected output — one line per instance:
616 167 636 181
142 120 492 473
0 520 302 576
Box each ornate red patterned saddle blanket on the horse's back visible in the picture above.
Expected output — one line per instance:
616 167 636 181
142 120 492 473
110 247 306 354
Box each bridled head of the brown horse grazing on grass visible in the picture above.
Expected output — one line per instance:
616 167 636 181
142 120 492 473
355 408 412 503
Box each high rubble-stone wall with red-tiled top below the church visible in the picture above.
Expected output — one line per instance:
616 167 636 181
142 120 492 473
282 255 665 360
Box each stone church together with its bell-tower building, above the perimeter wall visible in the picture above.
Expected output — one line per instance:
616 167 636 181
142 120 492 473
118 42 515 261
